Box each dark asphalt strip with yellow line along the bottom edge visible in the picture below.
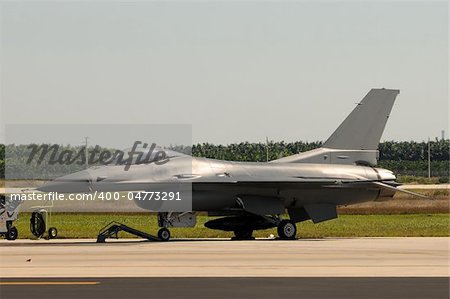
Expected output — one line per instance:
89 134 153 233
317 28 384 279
0 277 449 299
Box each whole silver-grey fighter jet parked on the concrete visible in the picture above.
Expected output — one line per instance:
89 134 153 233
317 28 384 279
39 88 422 241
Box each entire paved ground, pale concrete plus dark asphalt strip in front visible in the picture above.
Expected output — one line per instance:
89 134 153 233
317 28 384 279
0 238 450 299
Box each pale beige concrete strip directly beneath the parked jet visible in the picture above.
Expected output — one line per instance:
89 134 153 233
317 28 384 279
0 237 450 278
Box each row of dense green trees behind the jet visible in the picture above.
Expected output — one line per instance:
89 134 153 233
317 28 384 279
0 139 450 178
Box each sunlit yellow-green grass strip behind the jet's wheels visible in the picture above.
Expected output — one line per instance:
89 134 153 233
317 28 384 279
11 213 450 238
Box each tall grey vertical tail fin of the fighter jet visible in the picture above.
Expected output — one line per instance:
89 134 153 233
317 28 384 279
323 88 400 150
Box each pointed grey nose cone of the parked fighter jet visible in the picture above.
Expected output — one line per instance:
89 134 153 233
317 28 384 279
37 170 92 193
